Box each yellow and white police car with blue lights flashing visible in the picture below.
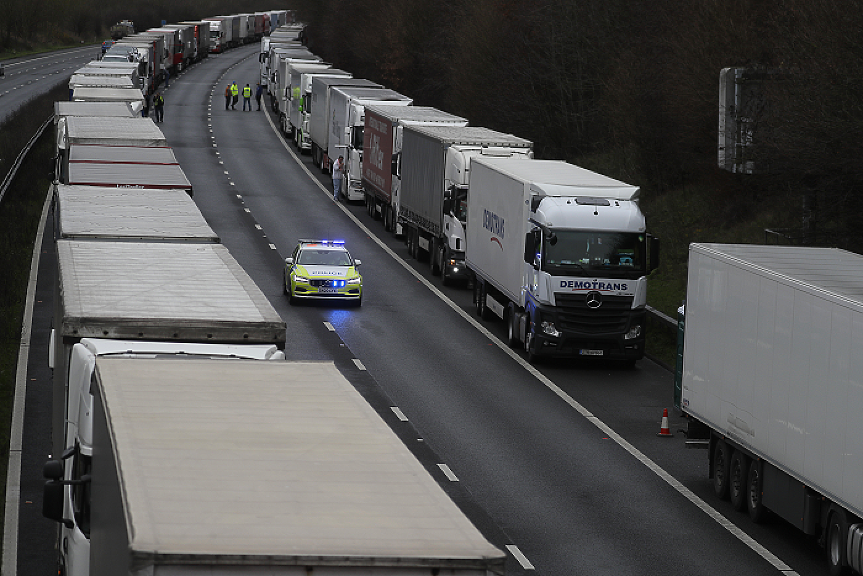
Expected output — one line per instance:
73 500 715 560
284 240 363 306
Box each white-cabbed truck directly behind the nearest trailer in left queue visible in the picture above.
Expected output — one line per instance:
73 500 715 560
49 240 285 576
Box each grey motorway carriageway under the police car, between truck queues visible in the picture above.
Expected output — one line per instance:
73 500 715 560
6 46 826 576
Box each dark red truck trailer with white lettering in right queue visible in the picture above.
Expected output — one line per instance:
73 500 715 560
361 104 467 234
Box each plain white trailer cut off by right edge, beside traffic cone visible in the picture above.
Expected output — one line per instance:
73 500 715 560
675 244 863 574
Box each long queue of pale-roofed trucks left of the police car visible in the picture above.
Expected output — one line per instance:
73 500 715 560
42 15 506 576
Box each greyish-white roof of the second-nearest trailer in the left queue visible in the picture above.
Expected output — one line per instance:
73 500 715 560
57 240 285 344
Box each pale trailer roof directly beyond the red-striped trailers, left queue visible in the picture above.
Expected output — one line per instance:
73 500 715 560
66 116 168 146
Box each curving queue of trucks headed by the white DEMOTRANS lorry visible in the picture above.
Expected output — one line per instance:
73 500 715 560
278 32 659 365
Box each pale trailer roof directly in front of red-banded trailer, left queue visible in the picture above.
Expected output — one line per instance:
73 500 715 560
54 184 219 242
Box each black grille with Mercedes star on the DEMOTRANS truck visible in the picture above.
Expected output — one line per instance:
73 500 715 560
554 293 632 334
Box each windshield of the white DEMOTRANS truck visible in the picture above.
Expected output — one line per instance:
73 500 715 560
543 230 645 277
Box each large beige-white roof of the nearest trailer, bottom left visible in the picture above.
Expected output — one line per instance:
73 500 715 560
92 358 504 574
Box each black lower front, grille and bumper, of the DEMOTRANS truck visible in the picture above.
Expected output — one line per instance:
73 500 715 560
526 300 646 361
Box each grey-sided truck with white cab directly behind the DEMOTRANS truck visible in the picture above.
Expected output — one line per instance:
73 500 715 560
400 125 533 283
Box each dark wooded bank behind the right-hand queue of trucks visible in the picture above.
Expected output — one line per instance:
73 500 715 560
293 0 863 252
